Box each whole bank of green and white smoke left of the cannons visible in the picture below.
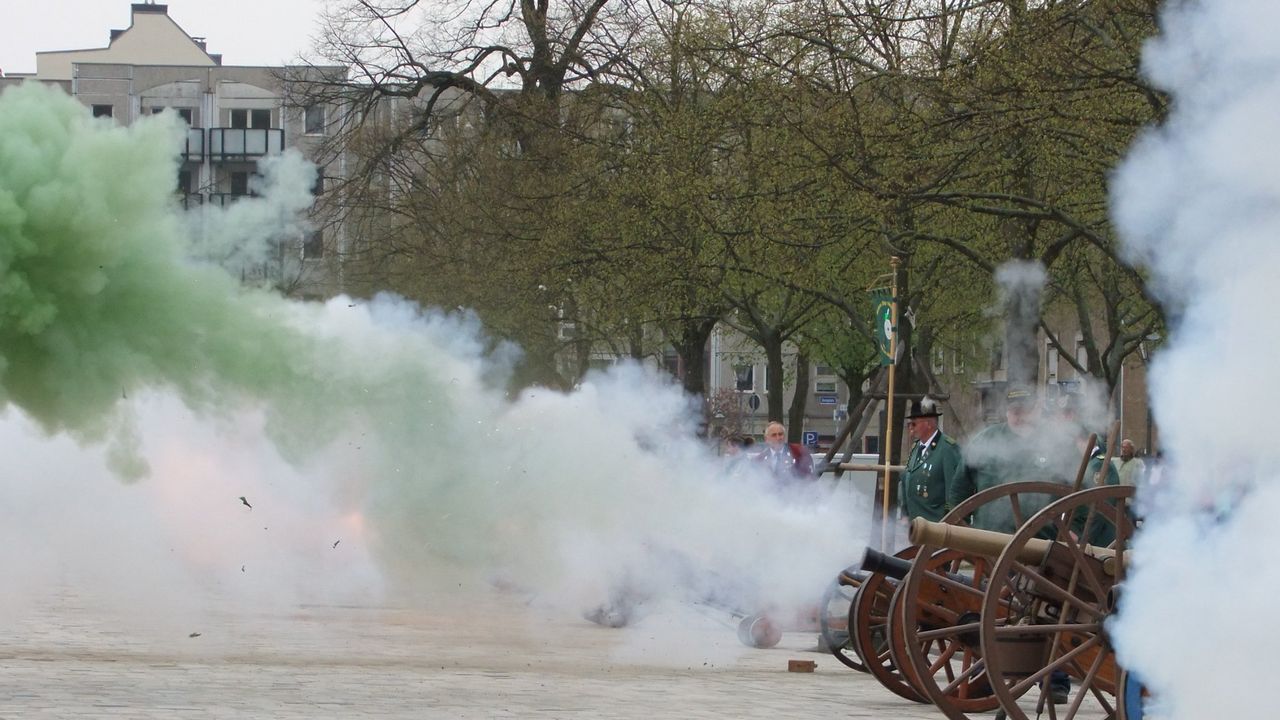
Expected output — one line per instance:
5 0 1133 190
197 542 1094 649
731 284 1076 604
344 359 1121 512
0 85 865 645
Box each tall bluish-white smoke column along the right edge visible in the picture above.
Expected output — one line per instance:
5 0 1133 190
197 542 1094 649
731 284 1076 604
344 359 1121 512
1114 0 1280 719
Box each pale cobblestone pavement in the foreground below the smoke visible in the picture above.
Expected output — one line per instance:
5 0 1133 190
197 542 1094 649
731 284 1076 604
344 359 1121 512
0 596 957 720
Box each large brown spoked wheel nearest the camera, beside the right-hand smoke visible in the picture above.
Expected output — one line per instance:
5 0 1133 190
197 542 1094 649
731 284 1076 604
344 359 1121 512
982 486 1134 720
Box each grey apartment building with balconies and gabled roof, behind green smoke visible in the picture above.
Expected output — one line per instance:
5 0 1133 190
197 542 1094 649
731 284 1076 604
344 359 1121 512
0 3 347 297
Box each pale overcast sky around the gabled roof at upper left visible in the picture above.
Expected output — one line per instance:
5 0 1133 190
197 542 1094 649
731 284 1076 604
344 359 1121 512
0 0 324 73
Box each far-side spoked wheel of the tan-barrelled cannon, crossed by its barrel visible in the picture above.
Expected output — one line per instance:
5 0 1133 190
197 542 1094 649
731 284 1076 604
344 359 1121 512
893 483 1071 720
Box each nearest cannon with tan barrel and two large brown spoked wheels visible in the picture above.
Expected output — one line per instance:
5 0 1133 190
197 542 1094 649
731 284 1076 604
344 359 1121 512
901 486 1135 720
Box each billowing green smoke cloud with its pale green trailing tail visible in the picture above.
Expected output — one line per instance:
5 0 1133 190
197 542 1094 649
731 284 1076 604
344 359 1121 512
0 83 519 566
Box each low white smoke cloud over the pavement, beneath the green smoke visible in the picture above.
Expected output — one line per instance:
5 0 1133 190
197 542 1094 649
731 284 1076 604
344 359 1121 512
0 296 867 661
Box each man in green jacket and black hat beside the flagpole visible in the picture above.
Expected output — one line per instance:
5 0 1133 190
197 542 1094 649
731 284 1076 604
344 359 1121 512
897 397 965 523
